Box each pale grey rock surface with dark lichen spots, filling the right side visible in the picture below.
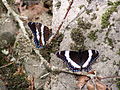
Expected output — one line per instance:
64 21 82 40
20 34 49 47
49 0 120 90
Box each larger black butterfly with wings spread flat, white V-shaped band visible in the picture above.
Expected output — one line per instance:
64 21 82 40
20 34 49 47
56 50 99 72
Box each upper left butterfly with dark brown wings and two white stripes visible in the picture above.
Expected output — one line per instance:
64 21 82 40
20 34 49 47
28 22 52 48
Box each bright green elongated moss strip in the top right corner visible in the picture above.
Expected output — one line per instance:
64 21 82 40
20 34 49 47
101 1 120 28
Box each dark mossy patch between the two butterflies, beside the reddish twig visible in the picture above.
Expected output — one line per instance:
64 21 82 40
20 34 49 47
40 34 64 61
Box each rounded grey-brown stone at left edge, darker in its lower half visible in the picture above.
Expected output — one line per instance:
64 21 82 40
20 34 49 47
0 16 18 48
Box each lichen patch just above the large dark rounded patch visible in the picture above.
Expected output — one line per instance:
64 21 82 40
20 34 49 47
77 18 92 29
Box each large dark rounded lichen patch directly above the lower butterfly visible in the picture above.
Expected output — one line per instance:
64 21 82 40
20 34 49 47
71 28 85 50
